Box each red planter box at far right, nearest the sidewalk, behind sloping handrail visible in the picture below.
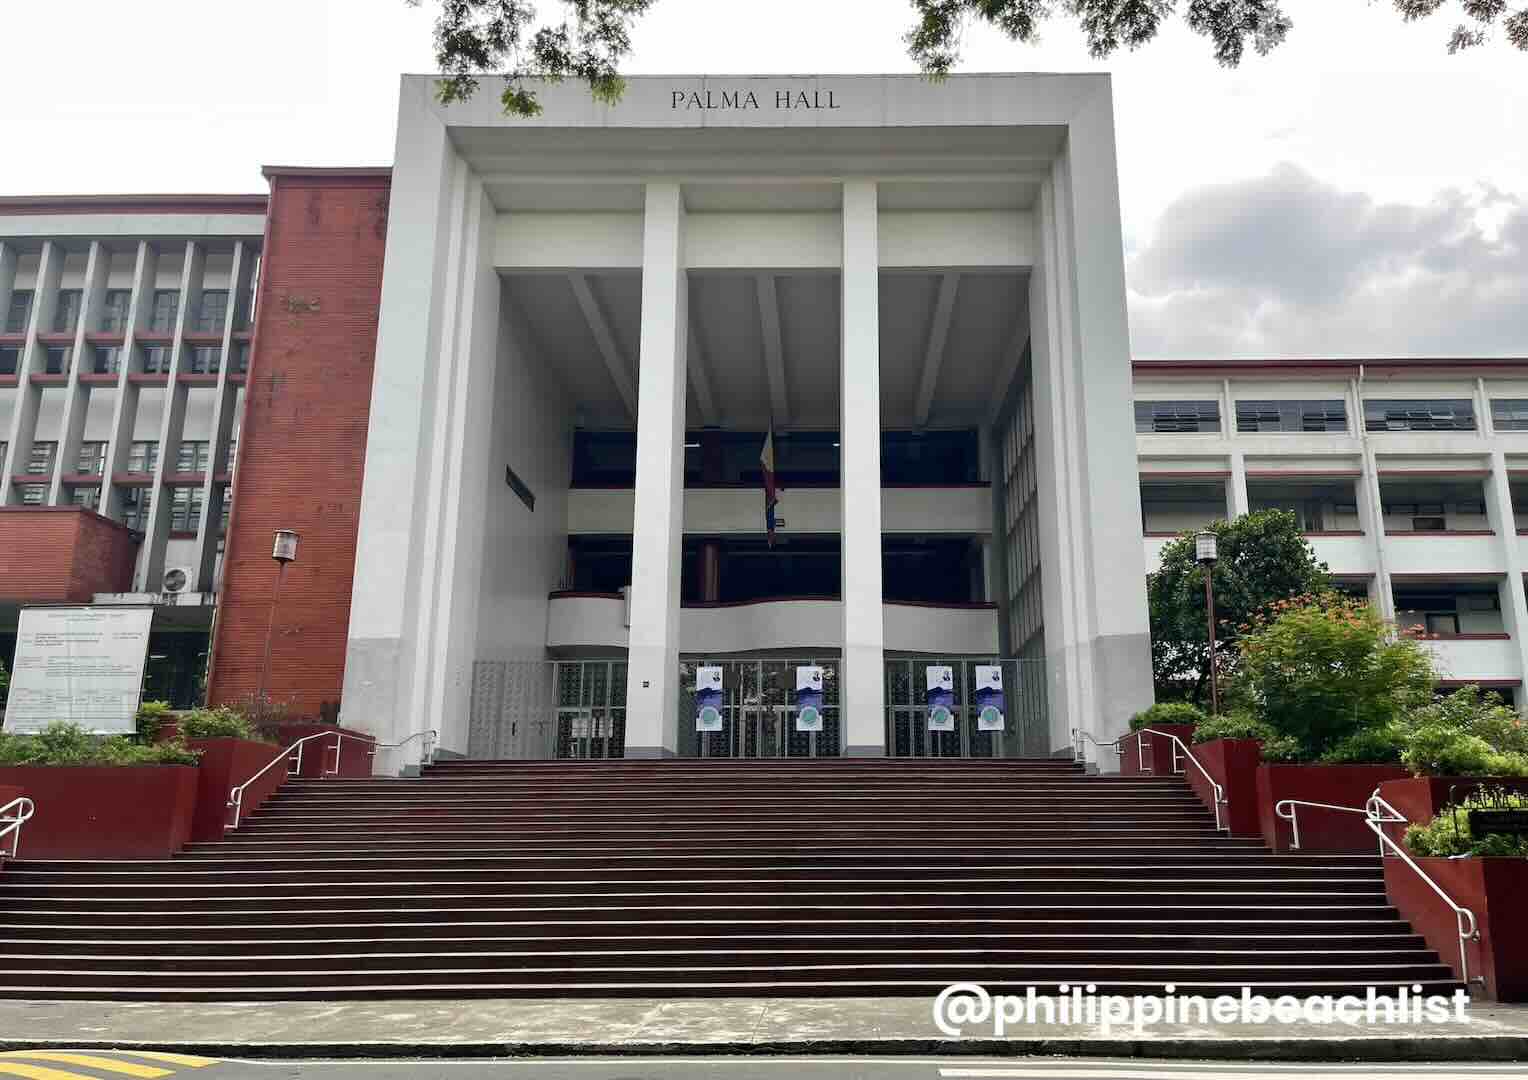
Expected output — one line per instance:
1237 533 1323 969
1384 857 1528 1002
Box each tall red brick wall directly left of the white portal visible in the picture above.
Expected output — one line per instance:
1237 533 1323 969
208 170 391 716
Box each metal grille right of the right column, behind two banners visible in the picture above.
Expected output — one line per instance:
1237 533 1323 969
886 657 1050 758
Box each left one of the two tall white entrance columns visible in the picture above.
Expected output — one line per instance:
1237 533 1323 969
626 180 689 758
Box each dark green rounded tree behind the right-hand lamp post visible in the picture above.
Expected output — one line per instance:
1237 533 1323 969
1146 510 1329 704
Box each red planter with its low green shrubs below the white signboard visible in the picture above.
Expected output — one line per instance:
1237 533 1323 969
0 724 197 859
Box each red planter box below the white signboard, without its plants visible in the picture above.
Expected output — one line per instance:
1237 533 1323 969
0 765 197 859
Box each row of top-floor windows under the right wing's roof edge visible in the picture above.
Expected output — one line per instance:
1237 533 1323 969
1135 397 1528 434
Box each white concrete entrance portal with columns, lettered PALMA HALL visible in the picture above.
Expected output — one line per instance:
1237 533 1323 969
342 75 1151 756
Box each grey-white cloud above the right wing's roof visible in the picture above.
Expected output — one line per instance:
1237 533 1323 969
1126 165 1528 357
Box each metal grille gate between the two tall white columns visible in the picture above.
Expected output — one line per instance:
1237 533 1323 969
678 657 843 758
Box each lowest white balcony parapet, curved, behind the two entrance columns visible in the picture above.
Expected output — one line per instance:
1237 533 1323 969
547 593 998 655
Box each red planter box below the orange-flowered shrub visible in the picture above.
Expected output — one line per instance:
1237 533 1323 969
1258 764 1410 854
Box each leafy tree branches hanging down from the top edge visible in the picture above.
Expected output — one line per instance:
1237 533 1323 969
405 0 1528 116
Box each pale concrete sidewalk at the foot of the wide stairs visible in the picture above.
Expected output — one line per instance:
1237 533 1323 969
0 998 1528 1062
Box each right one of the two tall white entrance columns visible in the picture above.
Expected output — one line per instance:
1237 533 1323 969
839 180 886 758
